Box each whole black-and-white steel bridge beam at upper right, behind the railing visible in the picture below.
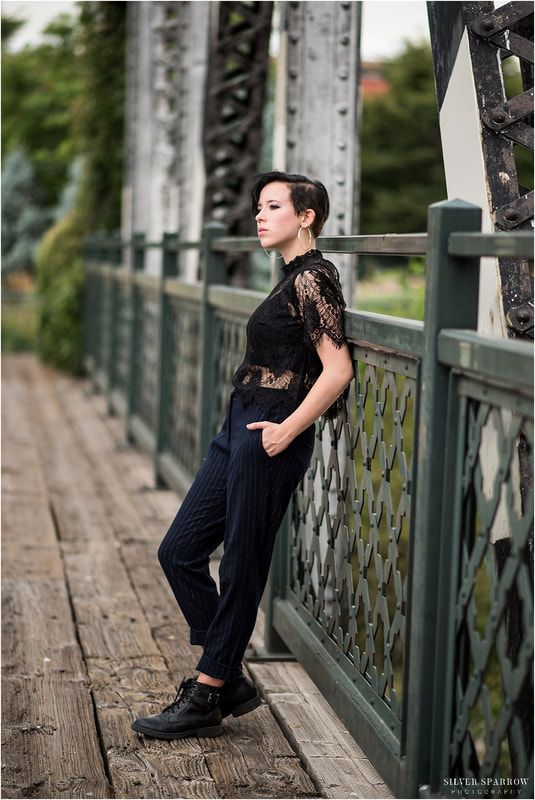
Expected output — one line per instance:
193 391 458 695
428 2 533 337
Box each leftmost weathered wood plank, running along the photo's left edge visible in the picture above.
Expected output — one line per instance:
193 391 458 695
2 358 111 798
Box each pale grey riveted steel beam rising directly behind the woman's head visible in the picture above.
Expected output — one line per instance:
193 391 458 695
283 2 362 303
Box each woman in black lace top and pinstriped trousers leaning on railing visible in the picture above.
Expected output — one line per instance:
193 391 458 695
132 172 353 739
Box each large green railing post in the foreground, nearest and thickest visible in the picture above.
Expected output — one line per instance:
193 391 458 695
401 200 481 797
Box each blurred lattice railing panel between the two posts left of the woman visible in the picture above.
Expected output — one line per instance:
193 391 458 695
163 296 200 475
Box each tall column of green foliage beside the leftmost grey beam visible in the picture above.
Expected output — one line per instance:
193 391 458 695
37 2 126 373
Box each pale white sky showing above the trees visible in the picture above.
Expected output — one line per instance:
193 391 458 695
1 0 429 61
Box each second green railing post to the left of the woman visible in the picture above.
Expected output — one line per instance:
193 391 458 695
153 233 179 486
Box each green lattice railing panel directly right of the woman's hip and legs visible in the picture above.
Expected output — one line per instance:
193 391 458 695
291 346 418 728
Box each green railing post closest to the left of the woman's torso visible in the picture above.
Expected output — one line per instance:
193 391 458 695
198 222 227 462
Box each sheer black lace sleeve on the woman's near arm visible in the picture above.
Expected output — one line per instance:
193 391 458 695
294 268 345 347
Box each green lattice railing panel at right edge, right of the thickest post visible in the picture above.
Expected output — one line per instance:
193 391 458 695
446 380 533 797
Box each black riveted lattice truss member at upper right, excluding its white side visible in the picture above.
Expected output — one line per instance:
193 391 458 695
463 2 533 338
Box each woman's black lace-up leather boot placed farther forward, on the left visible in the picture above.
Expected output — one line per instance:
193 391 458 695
132 678 223 739
